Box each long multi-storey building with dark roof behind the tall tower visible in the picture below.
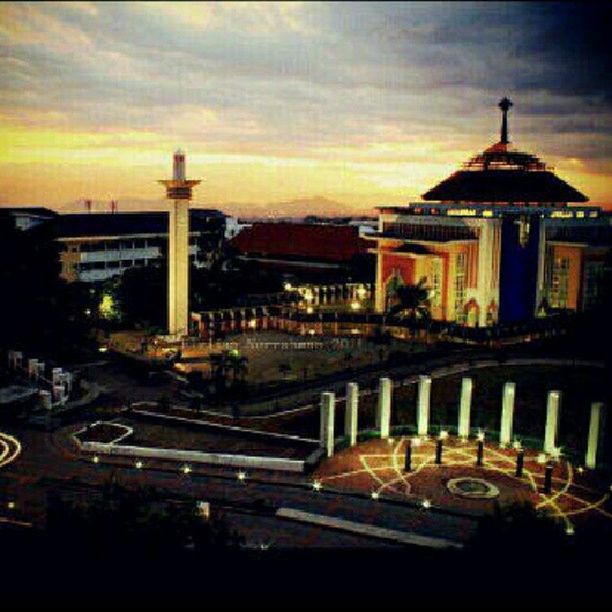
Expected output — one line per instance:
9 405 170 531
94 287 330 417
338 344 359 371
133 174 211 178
55 208 225 282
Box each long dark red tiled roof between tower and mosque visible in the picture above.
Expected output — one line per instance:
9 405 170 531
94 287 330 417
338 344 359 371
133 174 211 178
230 223 370 261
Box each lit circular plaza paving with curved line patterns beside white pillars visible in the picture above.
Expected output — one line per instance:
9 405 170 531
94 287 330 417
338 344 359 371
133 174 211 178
314 437 612 533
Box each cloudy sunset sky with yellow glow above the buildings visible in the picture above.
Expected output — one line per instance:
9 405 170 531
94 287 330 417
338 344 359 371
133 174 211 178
0 2 612 214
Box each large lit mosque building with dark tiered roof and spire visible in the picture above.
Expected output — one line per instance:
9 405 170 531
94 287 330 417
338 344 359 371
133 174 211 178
371 98 612 327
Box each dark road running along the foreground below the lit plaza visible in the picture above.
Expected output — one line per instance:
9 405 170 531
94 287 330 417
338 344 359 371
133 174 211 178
0 430 476 548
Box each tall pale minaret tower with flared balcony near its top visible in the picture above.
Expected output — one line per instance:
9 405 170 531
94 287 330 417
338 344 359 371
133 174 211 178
159 149 200 336
